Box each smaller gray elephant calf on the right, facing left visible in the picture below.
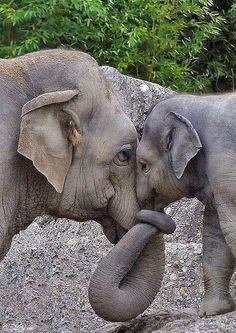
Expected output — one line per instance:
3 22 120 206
137 93 236 316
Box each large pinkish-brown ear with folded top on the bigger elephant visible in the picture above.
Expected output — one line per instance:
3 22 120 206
17 90 80 193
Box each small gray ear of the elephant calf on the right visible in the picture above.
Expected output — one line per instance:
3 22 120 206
167 112 202 179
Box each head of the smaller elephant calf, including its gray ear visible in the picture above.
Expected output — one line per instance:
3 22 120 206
137 97 202 210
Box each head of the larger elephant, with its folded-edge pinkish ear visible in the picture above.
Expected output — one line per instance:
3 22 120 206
18 50 139 242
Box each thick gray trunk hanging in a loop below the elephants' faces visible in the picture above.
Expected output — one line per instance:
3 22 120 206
89 223 165 321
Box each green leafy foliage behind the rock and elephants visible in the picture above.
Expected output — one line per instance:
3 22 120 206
0 0 236 91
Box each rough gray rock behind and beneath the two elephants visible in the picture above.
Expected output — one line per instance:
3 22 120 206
0 67 236 333
